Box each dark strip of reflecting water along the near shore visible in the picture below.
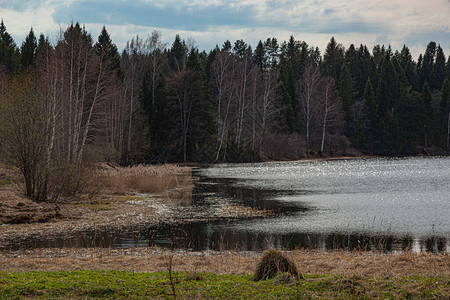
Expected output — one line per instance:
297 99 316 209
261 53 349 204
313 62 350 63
145 223 450 252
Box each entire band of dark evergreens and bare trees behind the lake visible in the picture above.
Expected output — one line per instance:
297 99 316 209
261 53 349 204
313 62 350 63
0 21 450 199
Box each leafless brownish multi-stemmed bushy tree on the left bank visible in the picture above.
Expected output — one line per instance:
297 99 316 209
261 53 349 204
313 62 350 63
0 73 48 201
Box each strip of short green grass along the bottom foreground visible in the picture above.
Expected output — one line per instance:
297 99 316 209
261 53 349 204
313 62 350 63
0 271 450 299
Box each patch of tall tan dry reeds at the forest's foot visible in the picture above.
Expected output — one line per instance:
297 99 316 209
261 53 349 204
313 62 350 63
98 165 192 194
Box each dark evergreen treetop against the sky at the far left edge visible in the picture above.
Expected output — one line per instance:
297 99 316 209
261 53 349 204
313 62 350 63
0 19 20 73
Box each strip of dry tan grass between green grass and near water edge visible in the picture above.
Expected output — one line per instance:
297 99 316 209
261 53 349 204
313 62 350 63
0 248 450 278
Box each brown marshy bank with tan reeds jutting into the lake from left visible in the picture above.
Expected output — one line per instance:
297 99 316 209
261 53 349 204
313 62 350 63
0 165 270 251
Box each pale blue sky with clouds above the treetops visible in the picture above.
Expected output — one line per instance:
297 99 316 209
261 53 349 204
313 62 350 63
0 0 450 59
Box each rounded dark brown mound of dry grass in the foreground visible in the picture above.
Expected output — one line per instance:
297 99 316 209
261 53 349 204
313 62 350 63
253 249 303 281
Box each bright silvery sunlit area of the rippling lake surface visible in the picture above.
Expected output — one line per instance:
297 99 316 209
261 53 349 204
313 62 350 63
202 158 450 237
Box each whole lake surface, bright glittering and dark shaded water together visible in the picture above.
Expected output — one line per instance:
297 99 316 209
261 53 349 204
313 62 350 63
4 157 450 252
